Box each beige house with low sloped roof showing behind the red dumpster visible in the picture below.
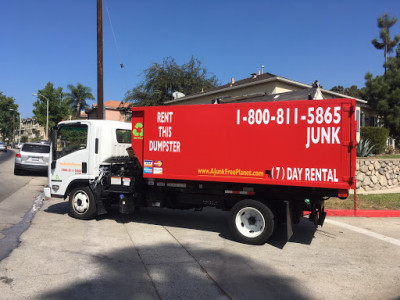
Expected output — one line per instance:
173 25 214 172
165 72 378 126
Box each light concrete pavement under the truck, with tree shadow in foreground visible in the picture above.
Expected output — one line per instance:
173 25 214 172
0 199 400 299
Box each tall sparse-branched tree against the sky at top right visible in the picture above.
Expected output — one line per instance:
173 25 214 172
372 13 400 74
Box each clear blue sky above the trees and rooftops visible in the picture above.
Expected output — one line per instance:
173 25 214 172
0 0 400 117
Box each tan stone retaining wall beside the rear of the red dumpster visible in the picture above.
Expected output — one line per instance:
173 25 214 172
356 158 400 192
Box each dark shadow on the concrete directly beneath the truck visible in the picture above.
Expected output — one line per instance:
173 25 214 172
44 201 317 249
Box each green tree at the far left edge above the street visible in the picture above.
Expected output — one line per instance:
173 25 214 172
0 92 19 142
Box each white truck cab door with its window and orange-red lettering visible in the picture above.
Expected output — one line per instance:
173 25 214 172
49 123 89 195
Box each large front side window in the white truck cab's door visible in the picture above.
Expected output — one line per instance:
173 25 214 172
56 124 88 159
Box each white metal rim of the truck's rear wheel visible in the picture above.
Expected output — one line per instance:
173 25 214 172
235 207 265 238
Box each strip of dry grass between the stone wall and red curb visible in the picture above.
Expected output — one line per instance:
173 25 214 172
325 194 400 210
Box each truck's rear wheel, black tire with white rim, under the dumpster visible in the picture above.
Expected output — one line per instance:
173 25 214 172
229 200 275 245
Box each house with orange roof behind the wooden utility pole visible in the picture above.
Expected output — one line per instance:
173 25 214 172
85 100 131 122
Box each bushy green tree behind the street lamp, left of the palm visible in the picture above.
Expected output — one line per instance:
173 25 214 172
33 82 71 134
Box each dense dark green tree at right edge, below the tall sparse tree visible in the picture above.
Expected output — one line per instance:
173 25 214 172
365 46 400 141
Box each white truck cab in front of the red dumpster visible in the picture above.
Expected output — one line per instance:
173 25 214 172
46 120 132 197
